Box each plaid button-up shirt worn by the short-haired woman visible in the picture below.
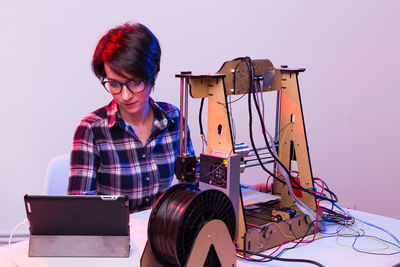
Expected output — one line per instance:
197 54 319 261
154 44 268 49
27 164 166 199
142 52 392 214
68 98 194 212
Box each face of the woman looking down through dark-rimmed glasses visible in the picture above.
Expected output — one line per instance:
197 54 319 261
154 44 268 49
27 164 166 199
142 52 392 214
104 64 152 121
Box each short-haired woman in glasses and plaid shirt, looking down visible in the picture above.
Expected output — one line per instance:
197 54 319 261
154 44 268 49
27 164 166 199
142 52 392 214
68 24 194 215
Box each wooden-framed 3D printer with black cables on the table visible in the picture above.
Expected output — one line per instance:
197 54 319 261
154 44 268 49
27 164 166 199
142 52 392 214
142 57 321 266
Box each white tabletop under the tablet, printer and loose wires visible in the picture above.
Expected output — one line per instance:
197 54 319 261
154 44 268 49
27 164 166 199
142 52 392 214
0 210 400 267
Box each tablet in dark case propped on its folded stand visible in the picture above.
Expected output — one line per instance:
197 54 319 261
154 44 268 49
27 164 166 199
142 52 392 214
24 195 130 257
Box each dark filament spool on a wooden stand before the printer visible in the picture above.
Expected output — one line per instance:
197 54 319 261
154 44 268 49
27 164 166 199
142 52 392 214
147 183 236 266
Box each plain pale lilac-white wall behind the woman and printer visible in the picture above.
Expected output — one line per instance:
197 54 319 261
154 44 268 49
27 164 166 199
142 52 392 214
0 0 400 232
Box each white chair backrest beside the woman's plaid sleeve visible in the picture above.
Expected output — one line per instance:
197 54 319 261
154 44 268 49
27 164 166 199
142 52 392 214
43 153 70 195
